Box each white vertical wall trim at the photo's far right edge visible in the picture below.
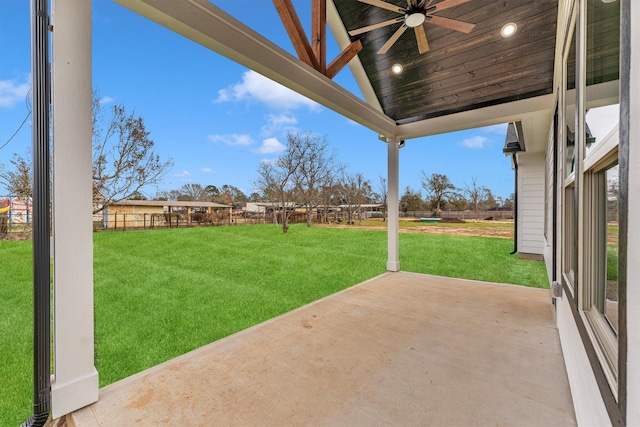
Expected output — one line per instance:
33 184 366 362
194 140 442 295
620 0 640 426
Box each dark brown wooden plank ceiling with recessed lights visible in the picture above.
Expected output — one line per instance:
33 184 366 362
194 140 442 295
334 0 558 124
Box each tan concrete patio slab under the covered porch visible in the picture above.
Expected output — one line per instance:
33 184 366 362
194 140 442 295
67 273 576 427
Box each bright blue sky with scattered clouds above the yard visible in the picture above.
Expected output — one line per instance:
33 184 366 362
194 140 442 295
0 0 514 201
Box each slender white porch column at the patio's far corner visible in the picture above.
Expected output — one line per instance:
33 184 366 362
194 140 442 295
386 138 400 271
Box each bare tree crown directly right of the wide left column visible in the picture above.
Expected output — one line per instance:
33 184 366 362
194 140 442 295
93 97 173 213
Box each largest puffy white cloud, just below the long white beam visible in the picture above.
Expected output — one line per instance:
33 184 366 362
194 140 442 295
214 70 318 110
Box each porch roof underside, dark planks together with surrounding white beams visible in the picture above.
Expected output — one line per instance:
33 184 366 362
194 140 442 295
114 0 557 139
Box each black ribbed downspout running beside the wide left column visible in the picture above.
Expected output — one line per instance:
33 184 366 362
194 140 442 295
22 0 51 427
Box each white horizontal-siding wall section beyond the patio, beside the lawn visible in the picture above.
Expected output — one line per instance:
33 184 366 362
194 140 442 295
517 153 545 255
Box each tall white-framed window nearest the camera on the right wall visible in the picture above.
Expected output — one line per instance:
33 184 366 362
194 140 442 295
576 0 620 399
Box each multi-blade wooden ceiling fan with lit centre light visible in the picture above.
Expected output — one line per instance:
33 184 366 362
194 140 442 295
349 0 476 54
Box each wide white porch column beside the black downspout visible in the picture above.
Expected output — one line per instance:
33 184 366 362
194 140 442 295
51 0 98 418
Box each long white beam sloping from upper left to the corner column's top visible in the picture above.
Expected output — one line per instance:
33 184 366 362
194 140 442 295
114 0 396 137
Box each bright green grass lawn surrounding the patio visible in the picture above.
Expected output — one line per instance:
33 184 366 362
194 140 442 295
0 225 547 426
